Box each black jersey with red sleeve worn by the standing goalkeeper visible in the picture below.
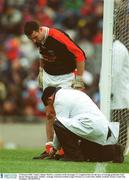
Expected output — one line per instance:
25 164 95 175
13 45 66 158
38 28 86 75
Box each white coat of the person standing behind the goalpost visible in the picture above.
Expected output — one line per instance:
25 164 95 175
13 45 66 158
111 40 129 109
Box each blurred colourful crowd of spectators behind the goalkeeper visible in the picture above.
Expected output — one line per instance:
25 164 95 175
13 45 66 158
0 0 103 120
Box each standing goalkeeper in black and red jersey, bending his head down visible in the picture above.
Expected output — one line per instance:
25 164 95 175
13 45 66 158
24 21 86 159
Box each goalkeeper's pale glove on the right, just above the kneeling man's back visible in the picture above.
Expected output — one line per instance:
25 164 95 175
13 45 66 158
71 75 85 89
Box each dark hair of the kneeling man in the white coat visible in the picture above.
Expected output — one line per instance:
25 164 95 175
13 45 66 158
41 86 56 106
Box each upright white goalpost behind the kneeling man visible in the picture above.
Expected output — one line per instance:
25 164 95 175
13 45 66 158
100 0 114 120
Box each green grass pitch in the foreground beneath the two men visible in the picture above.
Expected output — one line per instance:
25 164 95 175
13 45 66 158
0 149 129 173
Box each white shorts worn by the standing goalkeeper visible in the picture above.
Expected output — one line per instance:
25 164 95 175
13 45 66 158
43 71 75 89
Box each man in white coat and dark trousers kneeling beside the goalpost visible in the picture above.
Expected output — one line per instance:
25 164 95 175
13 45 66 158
42 87 124 163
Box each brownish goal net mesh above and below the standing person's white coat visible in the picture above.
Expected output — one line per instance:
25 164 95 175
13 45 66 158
111 0 129 153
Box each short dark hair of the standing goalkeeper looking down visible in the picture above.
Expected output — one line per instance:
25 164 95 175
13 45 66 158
24 21 40 36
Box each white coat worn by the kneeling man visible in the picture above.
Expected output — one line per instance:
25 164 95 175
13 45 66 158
54 89 119 147
